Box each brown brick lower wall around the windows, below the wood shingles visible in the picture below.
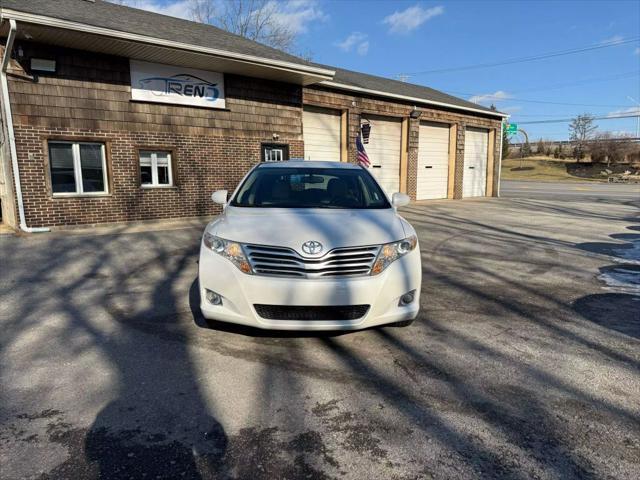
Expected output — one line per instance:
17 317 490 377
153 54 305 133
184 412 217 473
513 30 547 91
16 127 303 226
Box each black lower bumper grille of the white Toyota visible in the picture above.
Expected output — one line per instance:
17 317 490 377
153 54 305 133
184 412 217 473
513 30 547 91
254 304 369 321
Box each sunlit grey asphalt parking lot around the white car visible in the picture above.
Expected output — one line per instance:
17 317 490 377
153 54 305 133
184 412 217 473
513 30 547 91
0 190 640 480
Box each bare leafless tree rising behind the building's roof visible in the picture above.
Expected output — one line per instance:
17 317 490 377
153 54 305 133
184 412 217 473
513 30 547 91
190 0 295 51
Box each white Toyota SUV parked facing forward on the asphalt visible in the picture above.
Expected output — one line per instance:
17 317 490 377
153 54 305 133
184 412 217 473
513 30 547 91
199 161 422 330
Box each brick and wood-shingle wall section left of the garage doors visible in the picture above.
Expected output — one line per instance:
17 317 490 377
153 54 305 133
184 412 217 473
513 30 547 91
4 43 304 227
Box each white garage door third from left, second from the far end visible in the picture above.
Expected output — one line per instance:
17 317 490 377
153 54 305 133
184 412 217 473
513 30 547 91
416 122 449 200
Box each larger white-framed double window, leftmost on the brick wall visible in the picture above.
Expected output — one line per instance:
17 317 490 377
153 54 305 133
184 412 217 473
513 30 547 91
49 141 108 196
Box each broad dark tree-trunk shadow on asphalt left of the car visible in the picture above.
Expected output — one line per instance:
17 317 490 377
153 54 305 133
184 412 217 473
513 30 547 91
78 248 228 479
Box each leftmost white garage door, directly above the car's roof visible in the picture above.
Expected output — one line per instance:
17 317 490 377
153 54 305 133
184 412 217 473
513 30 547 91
302 106 340 162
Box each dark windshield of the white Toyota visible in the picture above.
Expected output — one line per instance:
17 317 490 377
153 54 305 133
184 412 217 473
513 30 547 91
230 167 391 208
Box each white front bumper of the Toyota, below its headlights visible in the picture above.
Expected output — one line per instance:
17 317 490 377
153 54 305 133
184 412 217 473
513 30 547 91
199 245 422 330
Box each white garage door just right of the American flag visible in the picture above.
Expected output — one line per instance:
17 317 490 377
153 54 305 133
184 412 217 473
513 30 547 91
364 116 402 195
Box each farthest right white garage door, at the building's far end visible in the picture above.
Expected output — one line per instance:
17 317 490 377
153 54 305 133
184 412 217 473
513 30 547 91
462 128 489 197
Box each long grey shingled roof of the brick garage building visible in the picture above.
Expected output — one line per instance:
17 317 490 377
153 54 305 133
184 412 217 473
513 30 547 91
0 0 504 116
